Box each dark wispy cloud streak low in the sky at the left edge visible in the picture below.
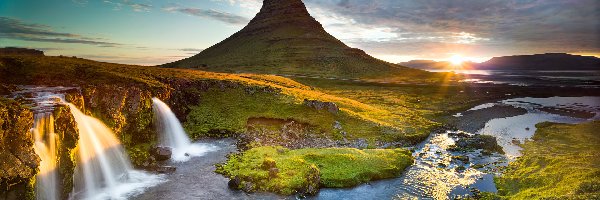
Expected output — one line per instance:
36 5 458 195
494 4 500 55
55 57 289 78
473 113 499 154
0 17 121 47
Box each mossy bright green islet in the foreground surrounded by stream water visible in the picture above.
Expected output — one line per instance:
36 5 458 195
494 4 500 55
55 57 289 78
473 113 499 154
217 146 412 195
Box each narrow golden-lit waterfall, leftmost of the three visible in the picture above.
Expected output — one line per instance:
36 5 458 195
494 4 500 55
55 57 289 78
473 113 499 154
31 112 59 200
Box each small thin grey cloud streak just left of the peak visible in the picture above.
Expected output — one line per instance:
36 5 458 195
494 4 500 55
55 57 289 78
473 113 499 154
163 5 250 25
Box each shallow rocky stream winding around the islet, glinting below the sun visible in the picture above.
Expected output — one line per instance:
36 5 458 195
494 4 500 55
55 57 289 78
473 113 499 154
131 97 600 200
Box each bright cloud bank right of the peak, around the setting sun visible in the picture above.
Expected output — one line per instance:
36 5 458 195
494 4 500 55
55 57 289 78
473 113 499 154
304 0 600 59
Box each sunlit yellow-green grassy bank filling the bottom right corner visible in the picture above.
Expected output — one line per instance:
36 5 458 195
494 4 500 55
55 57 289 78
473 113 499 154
496 121 600 199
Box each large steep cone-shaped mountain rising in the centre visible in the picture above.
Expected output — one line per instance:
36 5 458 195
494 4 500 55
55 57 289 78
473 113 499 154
163 0 425 78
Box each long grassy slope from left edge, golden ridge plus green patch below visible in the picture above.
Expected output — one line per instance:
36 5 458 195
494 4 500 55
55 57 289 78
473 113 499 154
0 56 436 142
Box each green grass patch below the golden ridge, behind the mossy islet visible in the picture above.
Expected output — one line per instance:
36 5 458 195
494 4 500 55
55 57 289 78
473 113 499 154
185 89 404 139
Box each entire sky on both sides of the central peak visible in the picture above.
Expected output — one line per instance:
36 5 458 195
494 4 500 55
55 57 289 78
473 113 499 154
0 0 600 65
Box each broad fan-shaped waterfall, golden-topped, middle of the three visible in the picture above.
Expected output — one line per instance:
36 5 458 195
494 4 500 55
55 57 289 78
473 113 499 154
68 103 162 199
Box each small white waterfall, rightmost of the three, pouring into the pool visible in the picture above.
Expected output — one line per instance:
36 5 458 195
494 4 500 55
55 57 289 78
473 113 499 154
152 98 214 162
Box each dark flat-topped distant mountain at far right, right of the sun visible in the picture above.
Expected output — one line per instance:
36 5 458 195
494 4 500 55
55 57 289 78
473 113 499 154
476 53 600 70
